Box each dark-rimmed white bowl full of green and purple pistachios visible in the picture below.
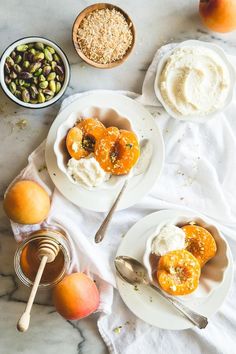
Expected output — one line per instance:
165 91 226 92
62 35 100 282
0 37 70 108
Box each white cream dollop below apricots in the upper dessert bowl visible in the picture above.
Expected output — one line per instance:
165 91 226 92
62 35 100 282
67 154 111 189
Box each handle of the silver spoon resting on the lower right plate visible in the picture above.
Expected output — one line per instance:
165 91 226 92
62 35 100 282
150 284 208 329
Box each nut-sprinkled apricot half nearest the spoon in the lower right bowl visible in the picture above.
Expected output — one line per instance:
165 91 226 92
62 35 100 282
157 250 201 295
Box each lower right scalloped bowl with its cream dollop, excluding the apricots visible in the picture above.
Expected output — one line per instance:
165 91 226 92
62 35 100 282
143 216 229 301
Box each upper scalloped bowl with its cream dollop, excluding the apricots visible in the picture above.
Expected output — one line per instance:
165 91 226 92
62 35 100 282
54 106 133 190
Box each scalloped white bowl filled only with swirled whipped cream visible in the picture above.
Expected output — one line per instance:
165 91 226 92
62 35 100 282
154 40 236 123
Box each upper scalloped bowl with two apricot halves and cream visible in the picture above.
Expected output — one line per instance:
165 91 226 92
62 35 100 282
54 106 140 190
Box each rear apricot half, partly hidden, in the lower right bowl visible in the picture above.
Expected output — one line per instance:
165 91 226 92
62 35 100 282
182 225 217 267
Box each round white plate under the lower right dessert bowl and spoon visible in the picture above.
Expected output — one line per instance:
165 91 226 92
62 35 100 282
116 210 233 330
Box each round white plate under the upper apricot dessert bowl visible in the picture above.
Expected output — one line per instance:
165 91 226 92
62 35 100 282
45 91 164 212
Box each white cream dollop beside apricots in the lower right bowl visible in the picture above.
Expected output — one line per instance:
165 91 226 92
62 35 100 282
152 225 185 256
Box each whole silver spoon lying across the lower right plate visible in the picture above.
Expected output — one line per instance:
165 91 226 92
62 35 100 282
115 256 208 329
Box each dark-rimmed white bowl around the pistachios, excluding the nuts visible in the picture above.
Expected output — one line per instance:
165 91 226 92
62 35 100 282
0 37 70 108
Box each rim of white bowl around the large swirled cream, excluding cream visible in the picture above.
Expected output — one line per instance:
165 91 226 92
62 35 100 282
154 40 236 123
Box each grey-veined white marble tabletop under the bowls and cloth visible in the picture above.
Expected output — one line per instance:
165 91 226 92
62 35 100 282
0 0 236 354
